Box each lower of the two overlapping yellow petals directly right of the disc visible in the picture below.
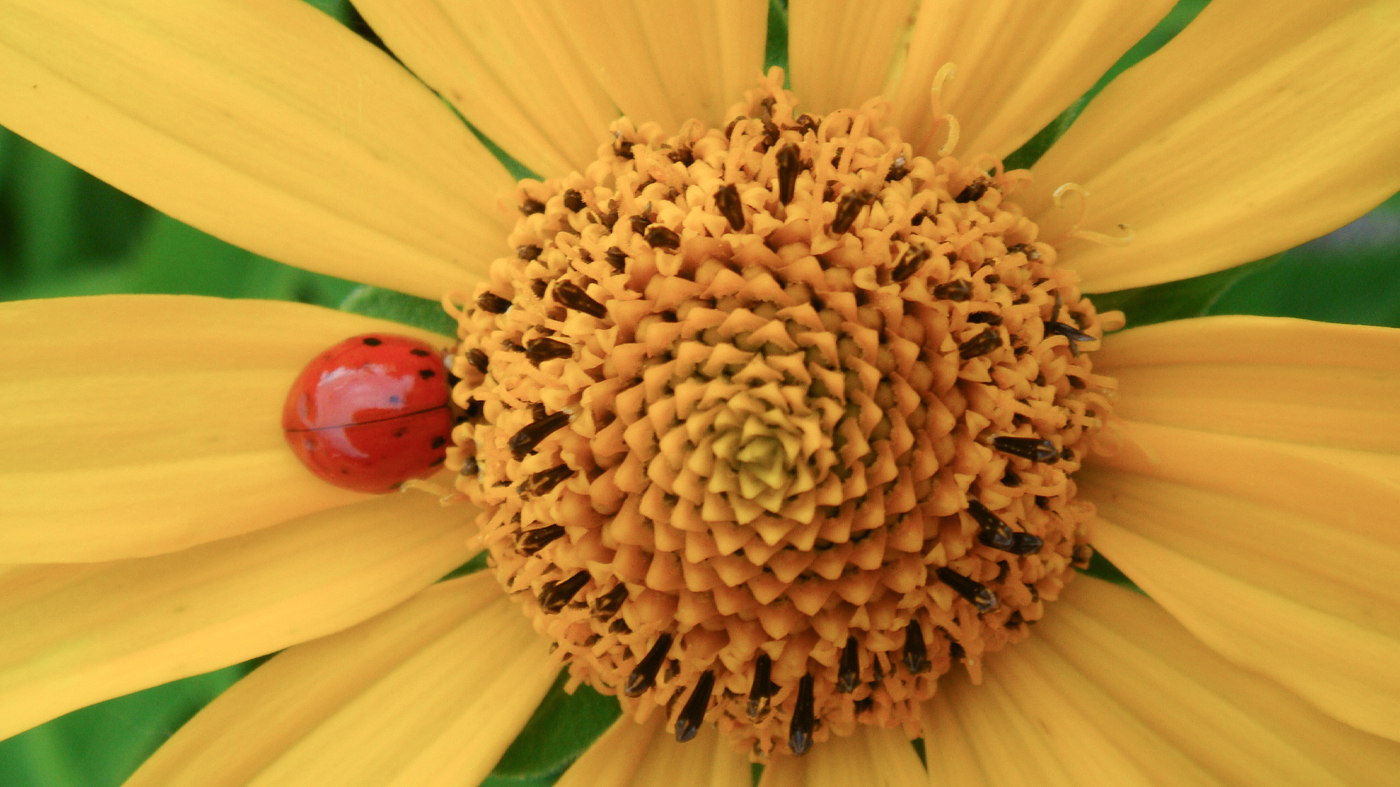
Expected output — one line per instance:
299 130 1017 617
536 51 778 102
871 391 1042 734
1077 422 1400 739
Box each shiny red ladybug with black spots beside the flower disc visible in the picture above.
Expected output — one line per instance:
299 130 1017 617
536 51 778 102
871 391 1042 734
281 333 454 493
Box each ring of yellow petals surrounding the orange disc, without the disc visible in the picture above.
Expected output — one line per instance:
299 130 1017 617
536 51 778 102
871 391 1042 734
0 0 1400 787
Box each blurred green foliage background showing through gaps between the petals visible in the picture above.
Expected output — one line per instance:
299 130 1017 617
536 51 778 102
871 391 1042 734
0 0 1400 787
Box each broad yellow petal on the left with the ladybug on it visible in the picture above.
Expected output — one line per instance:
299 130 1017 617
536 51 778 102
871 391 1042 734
0 295 447 563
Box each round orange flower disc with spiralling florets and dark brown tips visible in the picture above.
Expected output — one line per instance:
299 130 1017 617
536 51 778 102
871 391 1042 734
448 71 1112 759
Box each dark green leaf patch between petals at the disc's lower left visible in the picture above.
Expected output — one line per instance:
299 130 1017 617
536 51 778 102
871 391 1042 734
491 674 622 780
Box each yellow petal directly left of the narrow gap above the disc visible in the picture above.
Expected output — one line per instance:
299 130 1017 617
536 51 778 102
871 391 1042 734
554 0 769 133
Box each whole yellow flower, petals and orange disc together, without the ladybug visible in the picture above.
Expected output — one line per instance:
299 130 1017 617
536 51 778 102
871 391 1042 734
0 0 1400 786
